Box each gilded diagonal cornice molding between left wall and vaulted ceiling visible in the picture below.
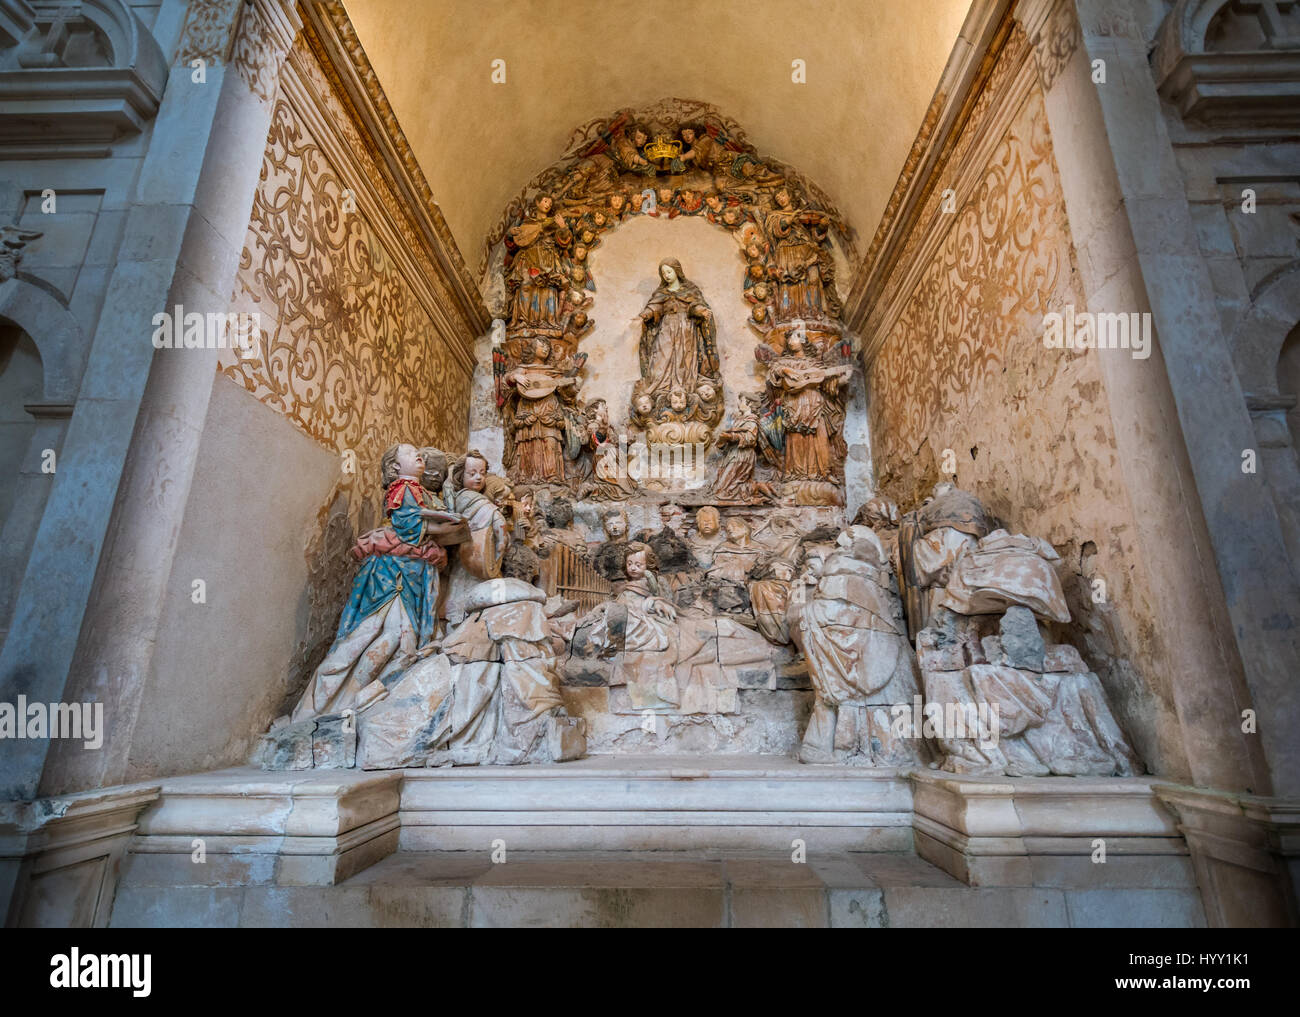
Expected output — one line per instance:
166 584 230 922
298 0 491 343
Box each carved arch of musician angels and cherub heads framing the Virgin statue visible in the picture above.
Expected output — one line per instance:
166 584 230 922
482 99 861 506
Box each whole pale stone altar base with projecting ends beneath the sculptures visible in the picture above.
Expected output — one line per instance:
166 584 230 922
17 756 1205 927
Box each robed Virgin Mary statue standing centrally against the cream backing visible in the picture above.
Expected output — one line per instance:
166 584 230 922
641 258 720 408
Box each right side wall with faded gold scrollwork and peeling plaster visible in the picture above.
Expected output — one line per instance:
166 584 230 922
867 29 1183 773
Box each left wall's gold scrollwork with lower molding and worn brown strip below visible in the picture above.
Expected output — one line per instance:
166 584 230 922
218 30 475 702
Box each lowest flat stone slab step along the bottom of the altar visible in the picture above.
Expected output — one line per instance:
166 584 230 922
112 849 1204 929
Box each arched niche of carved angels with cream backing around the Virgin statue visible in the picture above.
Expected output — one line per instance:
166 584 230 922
472 100 866 515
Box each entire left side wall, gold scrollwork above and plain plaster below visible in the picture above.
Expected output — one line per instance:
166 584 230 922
116 27 471 779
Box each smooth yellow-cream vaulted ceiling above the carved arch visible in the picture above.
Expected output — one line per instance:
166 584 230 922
345 0 970 274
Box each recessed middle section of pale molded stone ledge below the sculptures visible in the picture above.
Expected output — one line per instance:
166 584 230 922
399 756 913 852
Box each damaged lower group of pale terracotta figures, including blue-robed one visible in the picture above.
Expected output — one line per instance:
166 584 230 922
257 431 1140 776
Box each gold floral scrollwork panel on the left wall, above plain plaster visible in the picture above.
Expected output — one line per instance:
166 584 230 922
221 65 469 533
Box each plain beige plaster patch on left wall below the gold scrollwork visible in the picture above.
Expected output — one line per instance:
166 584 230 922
120 375 342 782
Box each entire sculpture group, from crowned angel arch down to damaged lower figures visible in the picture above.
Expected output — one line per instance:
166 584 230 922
260 103 1140 775
